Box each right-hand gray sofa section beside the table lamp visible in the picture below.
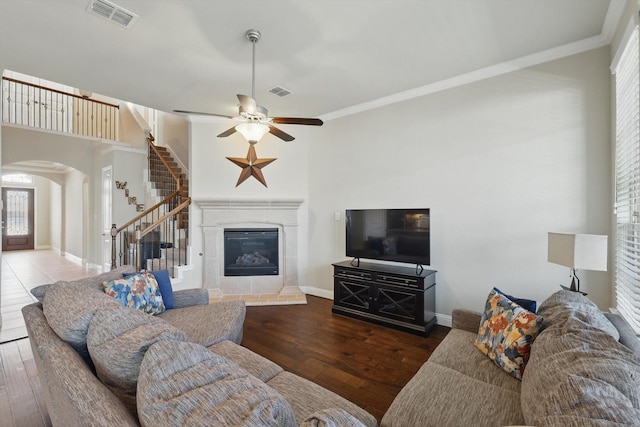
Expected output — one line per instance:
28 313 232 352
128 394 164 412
381 290 640 427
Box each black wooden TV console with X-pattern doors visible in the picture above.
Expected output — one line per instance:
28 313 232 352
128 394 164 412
331 261 436 335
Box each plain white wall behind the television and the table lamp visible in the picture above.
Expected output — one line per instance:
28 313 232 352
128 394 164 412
307 48 611 315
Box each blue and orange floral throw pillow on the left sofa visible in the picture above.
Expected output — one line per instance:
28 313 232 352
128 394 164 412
102 272 165 314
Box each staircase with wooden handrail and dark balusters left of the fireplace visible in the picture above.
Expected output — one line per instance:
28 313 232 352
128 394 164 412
111 135 191 277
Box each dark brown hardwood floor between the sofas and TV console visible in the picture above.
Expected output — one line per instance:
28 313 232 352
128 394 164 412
242 296 449 421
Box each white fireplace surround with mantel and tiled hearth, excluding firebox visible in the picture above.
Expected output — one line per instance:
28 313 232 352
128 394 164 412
195 199 306 305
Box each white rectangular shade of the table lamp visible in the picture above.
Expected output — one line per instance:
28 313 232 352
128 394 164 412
547 233 608 271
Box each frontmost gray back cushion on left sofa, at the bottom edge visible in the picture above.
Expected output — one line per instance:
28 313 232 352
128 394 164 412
138 341 296 427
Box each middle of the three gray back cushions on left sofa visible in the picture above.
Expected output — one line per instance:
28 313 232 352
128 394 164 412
87 307 187 414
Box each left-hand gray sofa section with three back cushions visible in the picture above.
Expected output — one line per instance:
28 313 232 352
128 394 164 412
22 267 377 427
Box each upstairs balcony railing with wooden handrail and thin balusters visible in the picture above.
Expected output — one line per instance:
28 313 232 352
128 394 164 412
2 77 118 140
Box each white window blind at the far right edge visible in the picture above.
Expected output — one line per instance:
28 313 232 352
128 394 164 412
614 20 640 333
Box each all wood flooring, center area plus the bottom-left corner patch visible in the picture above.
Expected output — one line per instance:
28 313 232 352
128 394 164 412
0 254 449 427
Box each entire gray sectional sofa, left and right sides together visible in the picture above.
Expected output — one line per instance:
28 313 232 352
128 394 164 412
23 268 640 427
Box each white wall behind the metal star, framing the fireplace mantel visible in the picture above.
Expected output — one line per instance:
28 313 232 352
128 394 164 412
184 118 313 287
